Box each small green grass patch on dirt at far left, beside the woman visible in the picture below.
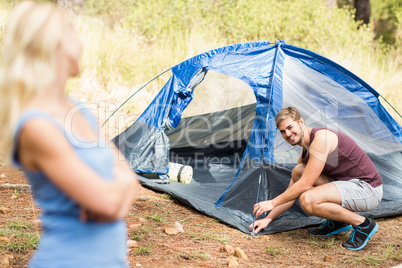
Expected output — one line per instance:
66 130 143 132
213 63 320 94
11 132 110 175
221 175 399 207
0 221 40 253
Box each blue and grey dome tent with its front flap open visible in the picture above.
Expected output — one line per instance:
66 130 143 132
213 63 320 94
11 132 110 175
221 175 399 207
114 41 402 234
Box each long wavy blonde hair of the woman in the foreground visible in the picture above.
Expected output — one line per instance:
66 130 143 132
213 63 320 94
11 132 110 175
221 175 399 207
0 1 70 162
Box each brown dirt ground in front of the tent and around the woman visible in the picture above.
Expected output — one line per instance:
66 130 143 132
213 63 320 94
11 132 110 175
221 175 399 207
0 166 402 267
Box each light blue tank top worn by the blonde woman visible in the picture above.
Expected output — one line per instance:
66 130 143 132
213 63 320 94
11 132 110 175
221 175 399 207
13 103 127 268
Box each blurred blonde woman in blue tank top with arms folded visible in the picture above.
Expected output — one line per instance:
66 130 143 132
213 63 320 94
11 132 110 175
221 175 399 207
0 2 138 268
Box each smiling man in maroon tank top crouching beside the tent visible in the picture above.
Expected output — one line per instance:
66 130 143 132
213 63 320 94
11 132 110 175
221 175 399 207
250 107 382 250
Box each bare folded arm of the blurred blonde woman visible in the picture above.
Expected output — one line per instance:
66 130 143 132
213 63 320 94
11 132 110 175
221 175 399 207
18 119 138 220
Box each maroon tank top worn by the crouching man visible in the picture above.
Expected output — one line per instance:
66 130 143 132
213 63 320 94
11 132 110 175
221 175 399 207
302 127 382 187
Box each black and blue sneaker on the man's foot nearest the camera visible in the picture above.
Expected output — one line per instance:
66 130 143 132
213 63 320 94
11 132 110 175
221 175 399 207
342 219 378 250
